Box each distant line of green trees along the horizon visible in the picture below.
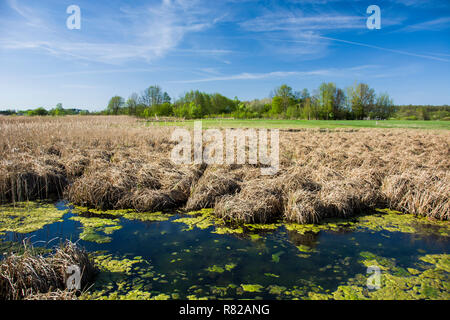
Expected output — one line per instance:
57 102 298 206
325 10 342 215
0 83 450 120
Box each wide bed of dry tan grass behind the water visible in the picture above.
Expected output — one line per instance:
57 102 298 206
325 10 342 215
0 116 450 223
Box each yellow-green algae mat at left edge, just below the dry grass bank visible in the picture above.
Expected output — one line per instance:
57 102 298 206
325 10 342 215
0 202 68 234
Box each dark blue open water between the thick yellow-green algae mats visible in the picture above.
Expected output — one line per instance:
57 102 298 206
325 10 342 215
0 202 450 299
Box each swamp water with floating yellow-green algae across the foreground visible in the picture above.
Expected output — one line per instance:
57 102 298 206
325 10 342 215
0 202 450 299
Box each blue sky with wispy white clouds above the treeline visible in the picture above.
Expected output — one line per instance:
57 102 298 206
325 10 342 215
0 0 450 110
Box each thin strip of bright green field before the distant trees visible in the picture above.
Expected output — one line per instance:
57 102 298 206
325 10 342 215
147 119 450 130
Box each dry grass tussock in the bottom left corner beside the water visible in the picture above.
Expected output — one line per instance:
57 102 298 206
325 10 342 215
0 241 96 300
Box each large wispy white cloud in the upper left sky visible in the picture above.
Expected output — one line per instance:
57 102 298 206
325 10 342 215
0 0 226 64
